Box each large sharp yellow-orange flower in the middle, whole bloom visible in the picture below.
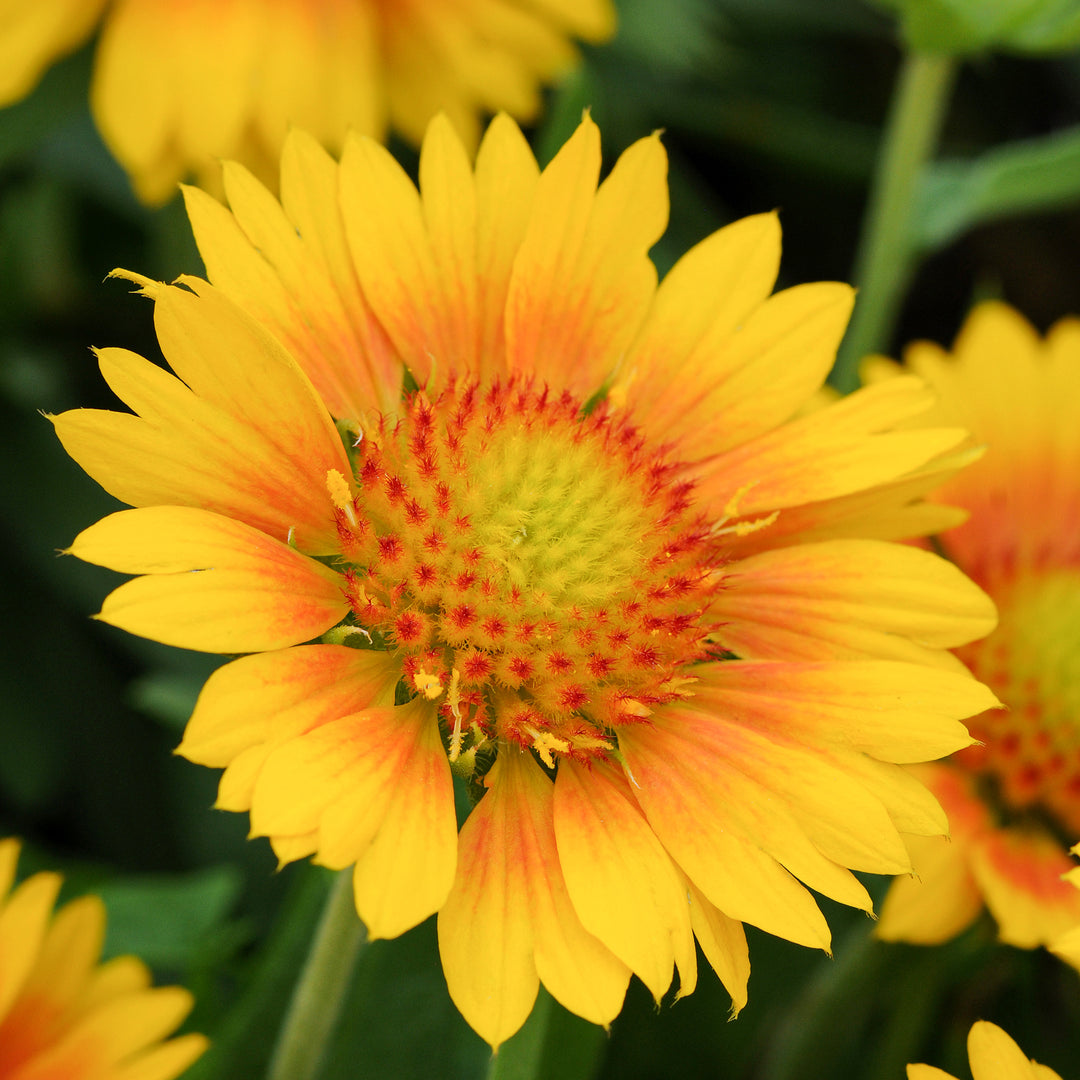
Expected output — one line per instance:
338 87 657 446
55 117 994 1044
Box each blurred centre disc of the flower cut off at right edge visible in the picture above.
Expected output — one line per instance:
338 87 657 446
961 570 1080 842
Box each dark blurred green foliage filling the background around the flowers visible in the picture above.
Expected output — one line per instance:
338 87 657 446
0 0 1080 1080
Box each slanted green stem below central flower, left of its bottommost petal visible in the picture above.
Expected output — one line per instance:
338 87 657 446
267 870 367 1080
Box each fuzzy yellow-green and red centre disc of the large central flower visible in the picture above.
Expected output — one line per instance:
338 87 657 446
332 379 717 765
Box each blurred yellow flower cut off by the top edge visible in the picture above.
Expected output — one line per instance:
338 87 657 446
0 0 615 204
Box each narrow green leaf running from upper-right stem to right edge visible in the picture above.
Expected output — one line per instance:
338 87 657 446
912 126 1080 251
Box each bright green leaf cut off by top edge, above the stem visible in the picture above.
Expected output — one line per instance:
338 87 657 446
877 0 1080 56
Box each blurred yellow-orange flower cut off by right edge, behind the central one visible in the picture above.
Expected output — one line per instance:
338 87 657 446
869 302 1080 948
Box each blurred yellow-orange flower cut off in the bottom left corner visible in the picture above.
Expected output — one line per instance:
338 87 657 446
0 840 206 1080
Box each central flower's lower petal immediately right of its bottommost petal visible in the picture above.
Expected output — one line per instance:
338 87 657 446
554 759 693 1001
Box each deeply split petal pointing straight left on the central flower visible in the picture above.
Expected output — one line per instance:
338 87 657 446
69 507 348 652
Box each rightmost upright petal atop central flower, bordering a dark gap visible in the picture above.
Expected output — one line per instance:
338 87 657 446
507 117 667 397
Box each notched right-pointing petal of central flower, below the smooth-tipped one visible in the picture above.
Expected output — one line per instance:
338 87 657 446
696 660 997 762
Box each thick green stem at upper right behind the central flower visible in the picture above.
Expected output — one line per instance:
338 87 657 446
832 52 956 393
